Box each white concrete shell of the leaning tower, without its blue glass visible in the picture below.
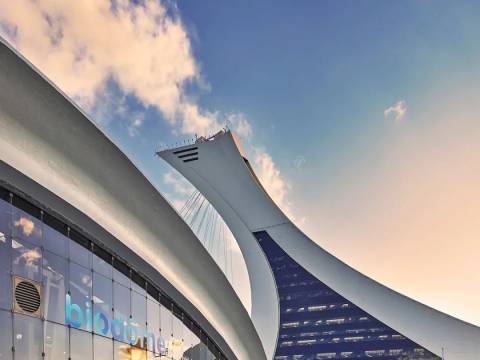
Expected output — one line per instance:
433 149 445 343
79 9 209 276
158 131 480 360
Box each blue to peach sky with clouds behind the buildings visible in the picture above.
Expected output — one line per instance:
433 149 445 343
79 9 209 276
0 0 480 325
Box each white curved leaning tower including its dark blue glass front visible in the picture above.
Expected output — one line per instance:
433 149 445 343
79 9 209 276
158 130 480 360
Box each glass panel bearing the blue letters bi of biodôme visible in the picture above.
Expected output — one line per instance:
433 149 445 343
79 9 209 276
66 262 92 331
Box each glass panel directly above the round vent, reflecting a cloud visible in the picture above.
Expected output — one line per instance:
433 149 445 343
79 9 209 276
12 239 42 282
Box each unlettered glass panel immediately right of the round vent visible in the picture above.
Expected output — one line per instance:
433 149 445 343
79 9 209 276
43 251 67 324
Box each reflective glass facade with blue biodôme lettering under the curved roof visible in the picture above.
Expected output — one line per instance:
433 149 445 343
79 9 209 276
0 188 226 360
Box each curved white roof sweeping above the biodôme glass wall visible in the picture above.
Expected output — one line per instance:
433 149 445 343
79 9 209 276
0 38 265 360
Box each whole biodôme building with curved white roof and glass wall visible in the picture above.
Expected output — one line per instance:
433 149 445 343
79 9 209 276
0 41 266 360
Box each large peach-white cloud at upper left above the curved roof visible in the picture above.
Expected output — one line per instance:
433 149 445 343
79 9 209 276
0 0 219 134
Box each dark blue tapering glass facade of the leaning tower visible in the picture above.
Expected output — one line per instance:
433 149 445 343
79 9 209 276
254 231 440 360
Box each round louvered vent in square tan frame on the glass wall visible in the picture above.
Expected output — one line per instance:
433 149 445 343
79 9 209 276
14 277 42 317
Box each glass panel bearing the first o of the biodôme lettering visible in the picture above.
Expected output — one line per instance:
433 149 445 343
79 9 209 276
93 272 113 338
